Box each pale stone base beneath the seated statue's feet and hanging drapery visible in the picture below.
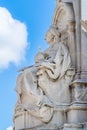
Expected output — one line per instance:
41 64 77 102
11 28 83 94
14 108 66 130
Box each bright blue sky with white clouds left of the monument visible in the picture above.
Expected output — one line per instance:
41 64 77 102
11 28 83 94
0 0 87 130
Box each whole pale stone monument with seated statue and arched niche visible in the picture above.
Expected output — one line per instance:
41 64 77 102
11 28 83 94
14 0 87 130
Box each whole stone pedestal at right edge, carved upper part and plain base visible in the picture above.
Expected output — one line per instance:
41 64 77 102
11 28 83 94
63 79 87 130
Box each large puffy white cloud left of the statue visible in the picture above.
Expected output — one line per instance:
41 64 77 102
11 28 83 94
0 7 27 69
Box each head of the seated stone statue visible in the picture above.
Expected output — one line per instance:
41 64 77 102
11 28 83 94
45 26 61 44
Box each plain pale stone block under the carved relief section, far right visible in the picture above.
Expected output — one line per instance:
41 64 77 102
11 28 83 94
67 103 87 123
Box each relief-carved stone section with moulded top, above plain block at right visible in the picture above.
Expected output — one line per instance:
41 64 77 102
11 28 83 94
70 79 87 103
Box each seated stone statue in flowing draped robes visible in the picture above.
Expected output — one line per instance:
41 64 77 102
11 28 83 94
14 26 74 127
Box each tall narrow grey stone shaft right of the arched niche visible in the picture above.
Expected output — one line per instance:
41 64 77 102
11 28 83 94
73 0 81 79
